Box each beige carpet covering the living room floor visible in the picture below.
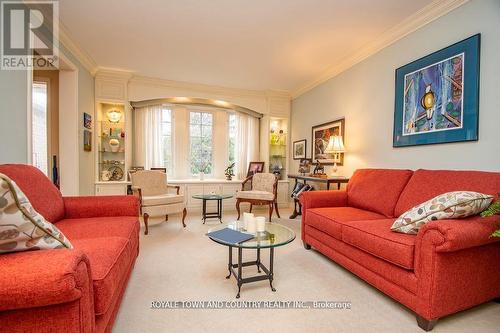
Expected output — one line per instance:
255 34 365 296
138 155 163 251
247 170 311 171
114 210 500 333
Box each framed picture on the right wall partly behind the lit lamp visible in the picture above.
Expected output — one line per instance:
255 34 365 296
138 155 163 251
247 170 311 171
312 118 345 165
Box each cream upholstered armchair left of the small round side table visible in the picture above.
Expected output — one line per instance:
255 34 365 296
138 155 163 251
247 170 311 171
131 170 187 235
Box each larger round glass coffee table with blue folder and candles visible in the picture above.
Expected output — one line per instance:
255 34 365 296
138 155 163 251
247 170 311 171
208 221 295 298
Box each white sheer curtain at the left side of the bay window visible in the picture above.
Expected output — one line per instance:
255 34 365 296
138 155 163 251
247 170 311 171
134 104 164 170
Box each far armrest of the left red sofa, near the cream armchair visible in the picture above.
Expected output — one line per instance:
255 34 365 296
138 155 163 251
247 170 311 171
63 195 139 219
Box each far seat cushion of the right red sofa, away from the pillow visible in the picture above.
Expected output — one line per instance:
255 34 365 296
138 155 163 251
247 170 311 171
305 207 384 240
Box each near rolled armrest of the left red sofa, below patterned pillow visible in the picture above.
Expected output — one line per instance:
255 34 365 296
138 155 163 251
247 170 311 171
0 249 92 311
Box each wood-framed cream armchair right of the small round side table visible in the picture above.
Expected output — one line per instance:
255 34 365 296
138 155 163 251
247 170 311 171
236 173 281 222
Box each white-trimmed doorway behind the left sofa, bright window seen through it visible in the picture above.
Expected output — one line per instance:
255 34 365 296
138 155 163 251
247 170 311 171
28 54 79 195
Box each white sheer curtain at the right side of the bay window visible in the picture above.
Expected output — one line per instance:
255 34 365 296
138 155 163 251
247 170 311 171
236 113 260 179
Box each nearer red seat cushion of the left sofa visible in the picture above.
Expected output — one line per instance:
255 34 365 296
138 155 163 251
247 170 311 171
73 237 135 315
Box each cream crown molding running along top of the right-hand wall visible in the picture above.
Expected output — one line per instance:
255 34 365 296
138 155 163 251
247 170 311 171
292 0 469 98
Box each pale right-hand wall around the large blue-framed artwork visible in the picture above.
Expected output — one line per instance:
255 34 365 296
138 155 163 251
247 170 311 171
291 0 500 176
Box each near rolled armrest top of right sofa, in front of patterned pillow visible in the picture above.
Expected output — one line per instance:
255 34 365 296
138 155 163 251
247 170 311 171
416 216 500 252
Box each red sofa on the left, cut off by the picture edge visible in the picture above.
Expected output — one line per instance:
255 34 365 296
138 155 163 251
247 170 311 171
0 164 139 332
